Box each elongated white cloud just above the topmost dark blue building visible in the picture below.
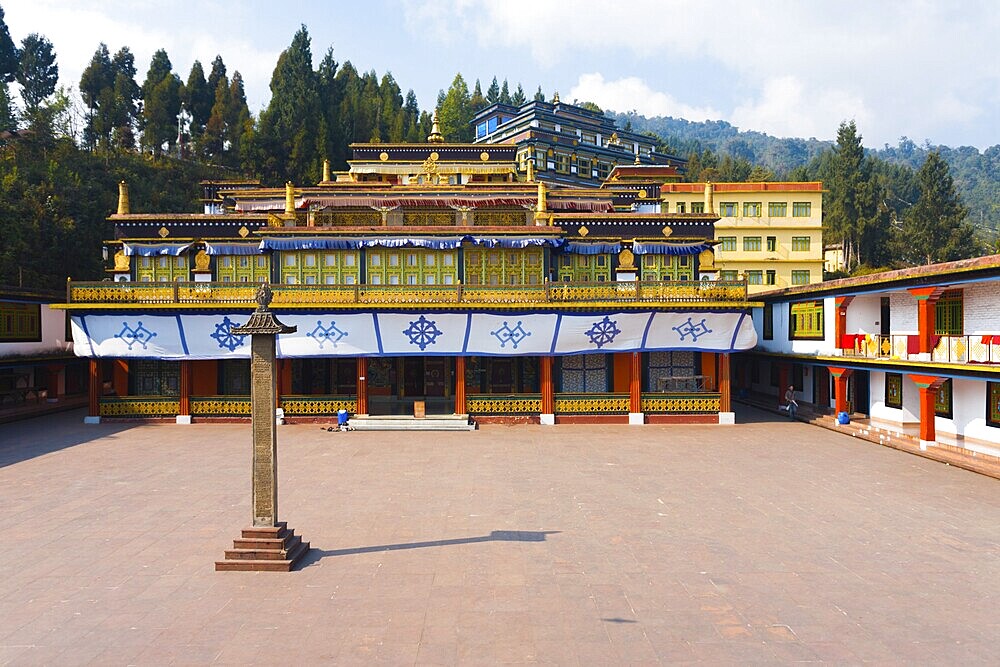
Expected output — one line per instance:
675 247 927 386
562 72 721 120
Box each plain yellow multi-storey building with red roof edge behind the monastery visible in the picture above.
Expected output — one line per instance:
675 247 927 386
660 182 823 293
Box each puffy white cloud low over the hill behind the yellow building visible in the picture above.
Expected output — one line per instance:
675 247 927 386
728 76 871 139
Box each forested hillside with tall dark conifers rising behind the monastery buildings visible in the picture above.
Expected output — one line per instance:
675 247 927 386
0 8 1000 288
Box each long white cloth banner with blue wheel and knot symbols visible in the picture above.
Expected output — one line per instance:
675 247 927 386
72 311 757 359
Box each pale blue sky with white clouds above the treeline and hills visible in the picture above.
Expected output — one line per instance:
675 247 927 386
0 0 1000 150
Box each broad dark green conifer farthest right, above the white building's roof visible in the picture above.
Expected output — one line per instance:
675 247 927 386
903 151 979 264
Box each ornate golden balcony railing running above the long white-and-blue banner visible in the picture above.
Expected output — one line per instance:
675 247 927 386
66 281 747 308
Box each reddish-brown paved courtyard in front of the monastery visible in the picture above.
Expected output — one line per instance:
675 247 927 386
0 410 1000 665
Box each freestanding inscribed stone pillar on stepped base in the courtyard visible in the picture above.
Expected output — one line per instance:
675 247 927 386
215 283 309 572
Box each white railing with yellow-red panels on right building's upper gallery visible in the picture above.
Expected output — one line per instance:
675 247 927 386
844 334 1000 364
